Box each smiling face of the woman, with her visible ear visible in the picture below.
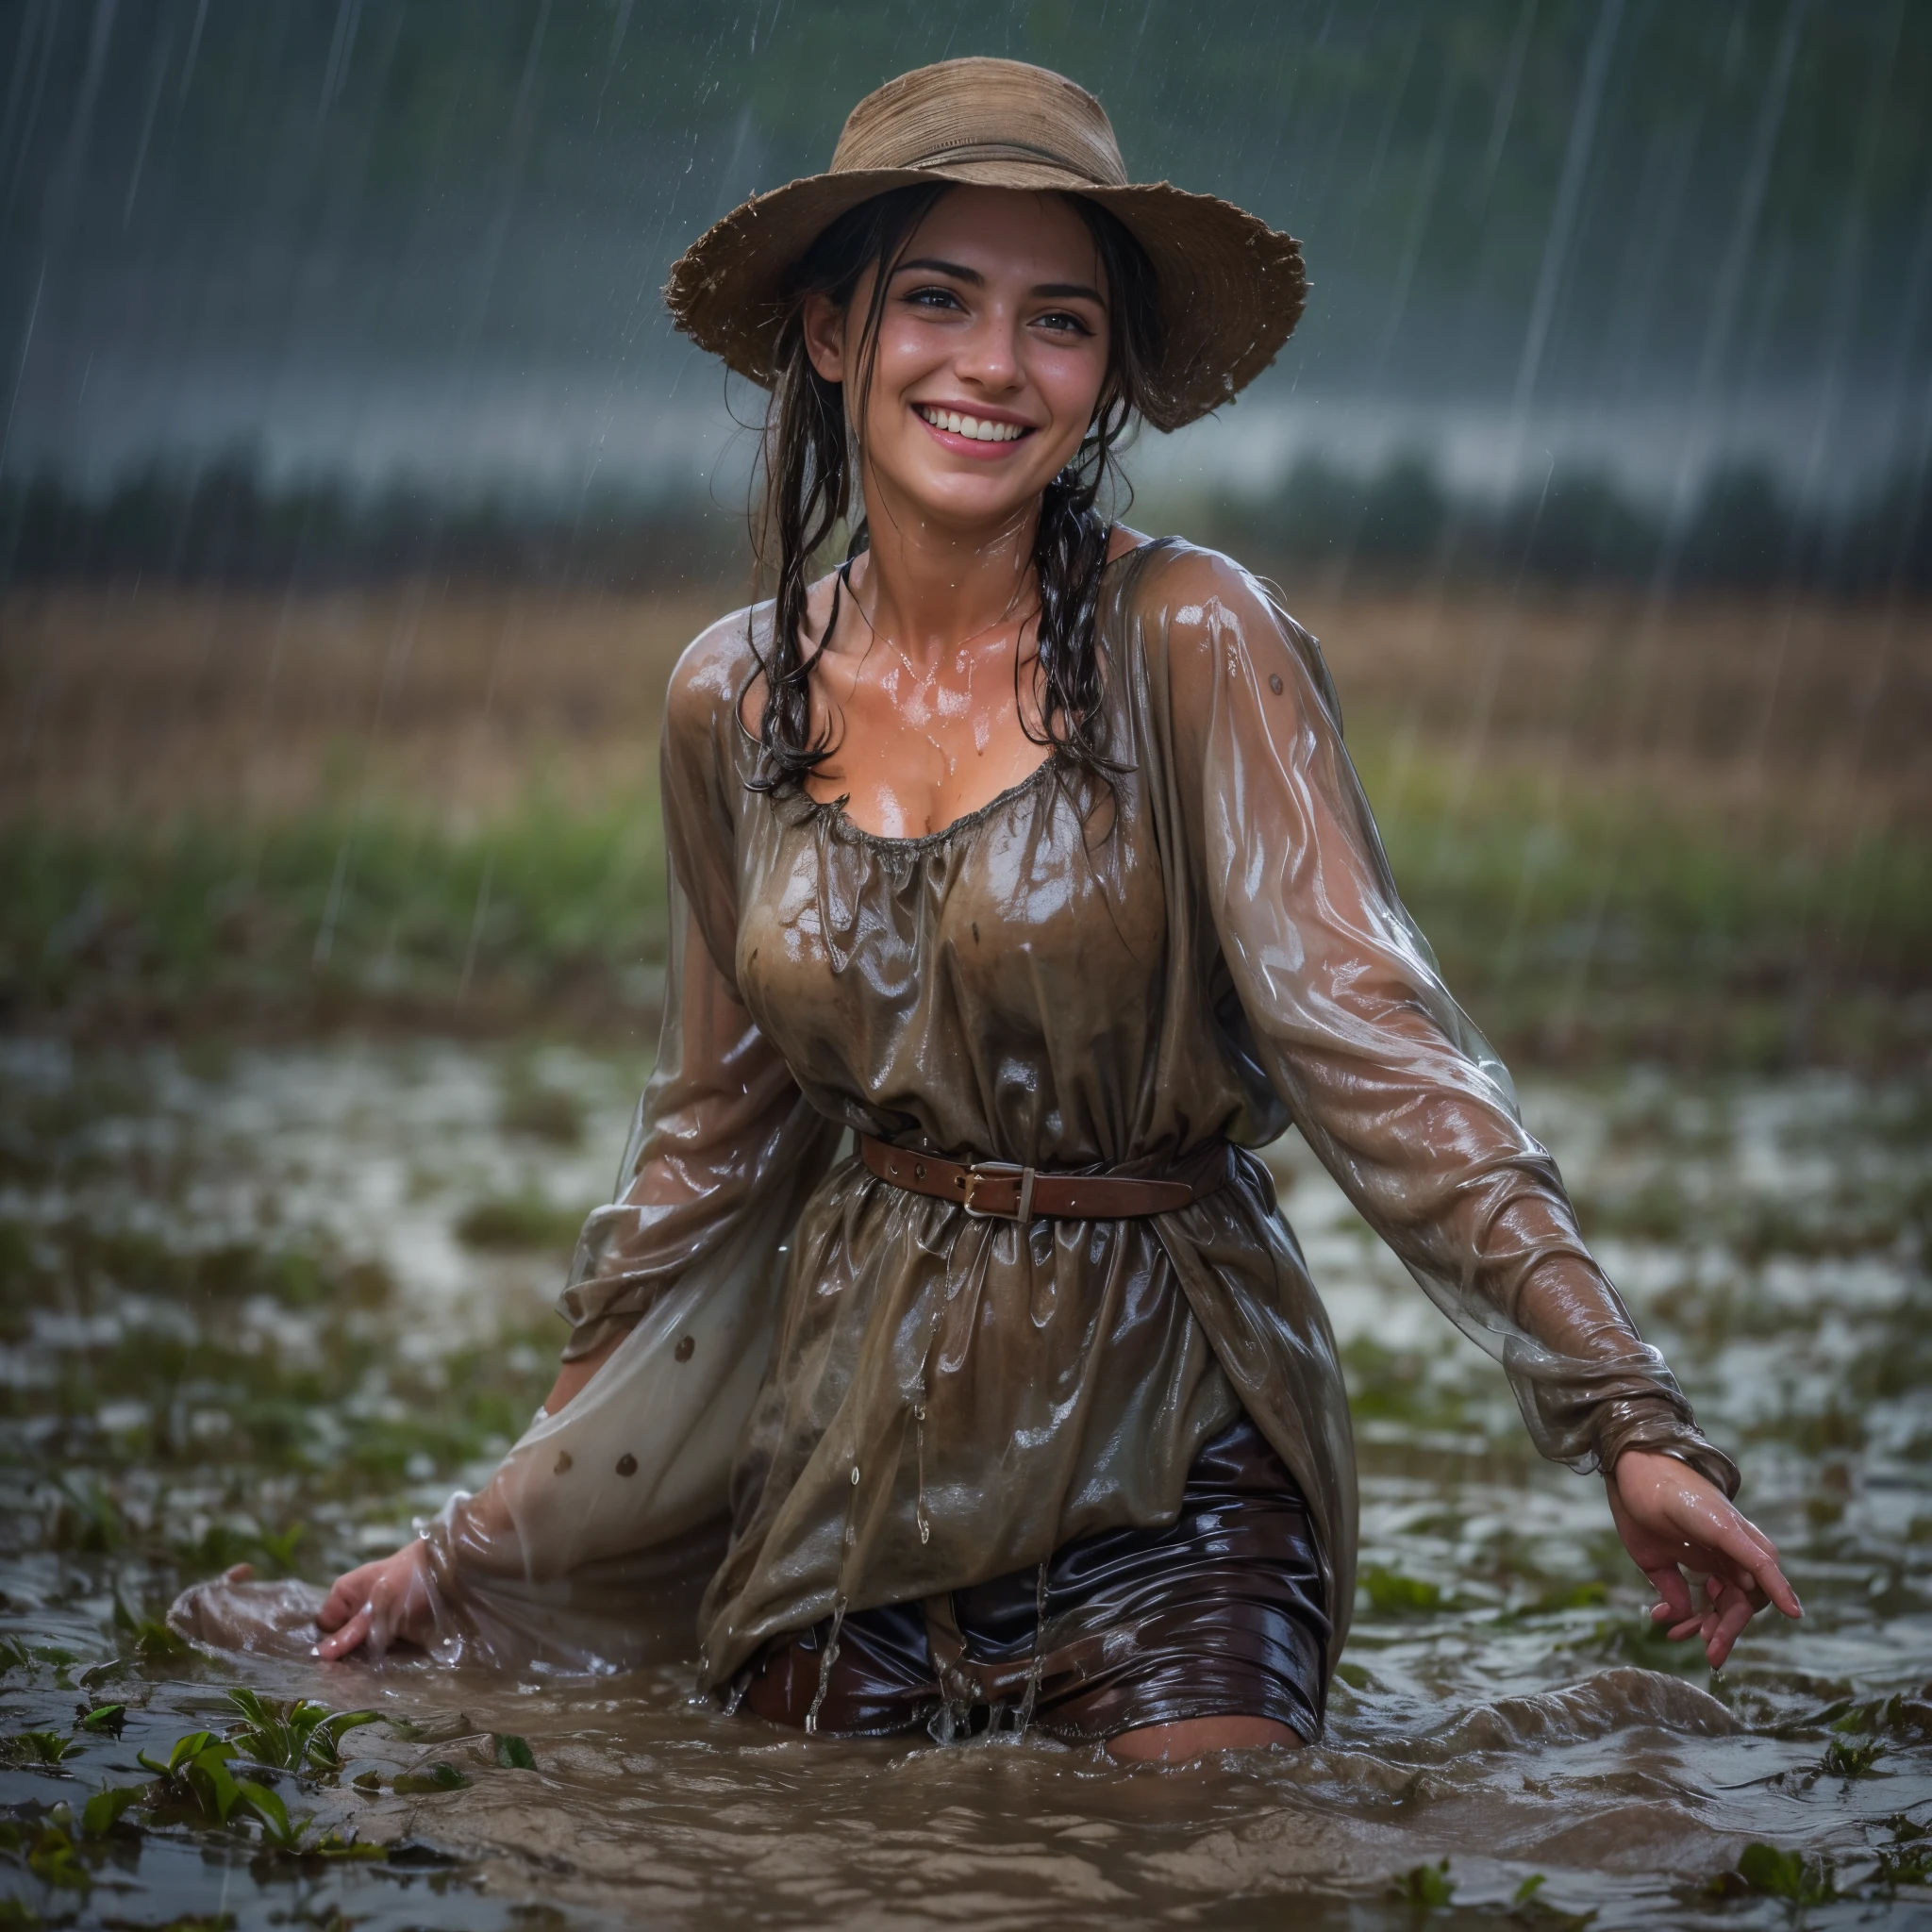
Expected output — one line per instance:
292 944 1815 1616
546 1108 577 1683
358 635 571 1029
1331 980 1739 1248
804 188 1108 533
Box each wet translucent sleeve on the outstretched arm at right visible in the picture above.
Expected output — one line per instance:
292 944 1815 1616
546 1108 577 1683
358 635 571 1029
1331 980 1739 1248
1163 553 1739 1493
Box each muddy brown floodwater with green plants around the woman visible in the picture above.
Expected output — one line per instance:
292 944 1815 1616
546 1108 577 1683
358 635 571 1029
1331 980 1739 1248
0 1043 1932 1926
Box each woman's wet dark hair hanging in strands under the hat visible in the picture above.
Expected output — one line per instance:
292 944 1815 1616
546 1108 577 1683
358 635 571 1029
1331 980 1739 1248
752 184 1159 791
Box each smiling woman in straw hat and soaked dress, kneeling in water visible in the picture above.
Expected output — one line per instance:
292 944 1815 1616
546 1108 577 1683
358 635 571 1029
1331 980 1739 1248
319 59 1799 1758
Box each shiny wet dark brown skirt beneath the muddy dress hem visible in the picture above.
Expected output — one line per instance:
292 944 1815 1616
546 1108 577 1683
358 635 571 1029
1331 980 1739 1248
732 1416 1329 1742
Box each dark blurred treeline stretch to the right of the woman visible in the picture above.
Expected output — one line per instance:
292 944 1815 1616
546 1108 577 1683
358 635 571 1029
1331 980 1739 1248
1206 456 1932 595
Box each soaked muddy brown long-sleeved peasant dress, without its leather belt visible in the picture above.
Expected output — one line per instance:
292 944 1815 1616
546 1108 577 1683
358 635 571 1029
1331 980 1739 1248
411 541 1737 1731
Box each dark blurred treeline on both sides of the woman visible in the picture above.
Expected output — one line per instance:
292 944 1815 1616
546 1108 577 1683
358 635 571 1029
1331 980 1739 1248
0 456 1932 595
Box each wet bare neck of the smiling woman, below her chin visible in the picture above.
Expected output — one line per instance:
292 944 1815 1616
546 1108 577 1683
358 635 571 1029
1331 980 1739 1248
852 476 1040 665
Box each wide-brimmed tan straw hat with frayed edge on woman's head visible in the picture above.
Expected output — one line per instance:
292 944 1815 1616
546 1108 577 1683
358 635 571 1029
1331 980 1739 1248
665 58 1307 429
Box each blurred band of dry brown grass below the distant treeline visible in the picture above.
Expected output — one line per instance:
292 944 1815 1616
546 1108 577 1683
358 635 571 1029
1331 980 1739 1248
0 583 1932 842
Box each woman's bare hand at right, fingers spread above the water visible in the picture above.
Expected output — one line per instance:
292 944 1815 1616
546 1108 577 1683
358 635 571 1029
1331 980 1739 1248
1604 1449 1805 1669
